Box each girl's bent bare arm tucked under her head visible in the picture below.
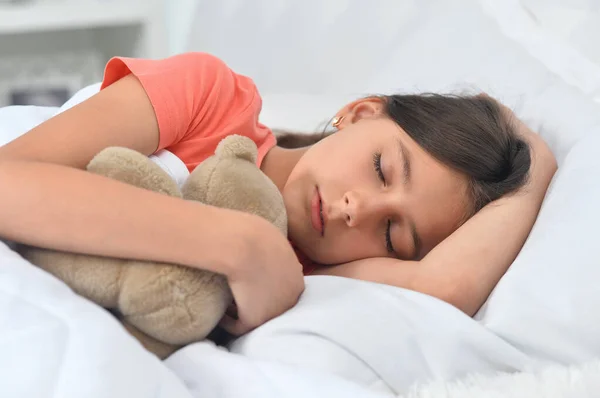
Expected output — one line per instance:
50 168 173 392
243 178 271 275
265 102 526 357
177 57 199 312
318 110 557 316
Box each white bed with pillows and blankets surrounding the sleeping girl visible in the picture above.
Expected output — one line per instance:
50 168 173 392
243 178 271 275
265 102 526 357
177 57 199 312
0 0 600 398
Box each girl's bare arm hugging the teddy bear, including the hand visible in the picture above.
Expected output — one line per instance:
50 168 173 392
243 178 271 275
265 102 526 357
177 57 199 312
0 76 304 333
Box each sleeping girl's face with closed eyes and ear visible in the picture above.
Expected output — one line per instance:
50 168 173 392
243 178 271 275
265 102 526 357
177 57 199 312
283 99 468 264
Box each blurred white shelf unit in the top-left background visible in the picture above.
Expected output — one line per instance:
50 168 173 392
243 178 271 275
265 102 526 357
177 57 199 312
0 0 171 106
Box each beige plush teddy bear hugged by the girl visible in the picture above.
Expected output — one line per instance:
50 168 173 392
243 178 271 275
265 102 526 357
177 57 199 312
18 136 287 358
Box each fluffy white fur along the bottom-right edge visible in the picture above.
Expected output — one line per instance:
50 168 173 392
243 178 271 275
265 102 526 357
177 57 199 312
399 360 600 398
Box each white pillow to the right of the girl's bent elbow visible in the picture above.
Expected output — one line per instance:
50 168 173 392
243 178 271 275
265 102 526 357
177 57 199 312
478 128 600 363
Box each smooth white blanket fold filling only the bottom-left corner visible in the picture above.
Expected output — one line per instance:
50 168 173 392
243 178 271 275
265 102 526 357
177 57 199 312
0 243 190 398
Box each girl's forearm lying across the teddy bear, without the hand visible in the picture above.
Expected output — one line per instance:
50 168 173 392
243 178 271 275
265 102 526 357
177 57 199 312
0 161 241 275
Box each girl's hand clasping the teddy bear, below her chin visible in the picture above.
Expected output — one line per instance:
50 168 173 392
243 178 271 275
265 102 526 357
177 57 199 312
221 214 304 335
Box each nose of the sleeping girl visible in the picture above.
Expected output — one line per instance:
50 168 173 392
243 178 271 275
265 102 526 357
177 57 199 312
339 191 396 227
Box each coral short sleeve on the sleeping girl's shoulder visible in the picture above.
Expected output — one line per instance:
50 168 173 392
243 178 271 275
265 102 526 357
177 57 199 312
101 52 276 170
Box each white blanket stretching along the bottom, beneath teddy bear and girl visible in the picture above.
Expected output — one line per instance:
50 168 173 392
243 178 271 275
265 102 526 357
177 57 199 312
0 239 535 398
